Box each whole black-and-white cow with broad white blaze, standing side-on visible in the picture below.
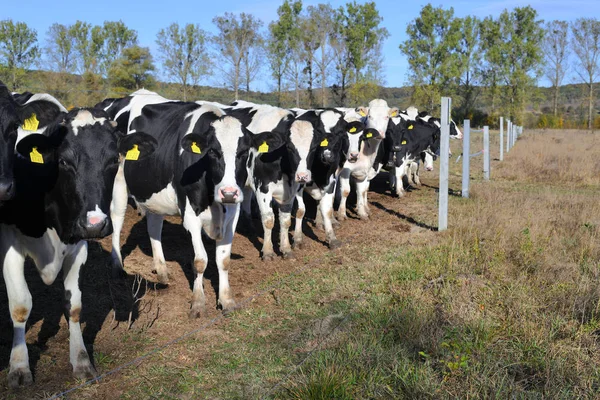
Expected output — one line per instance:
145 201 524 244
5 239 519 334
111 95 280 318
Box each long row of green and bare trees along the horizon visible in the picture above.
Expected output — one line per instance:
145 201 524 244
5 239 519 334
0 0 600 127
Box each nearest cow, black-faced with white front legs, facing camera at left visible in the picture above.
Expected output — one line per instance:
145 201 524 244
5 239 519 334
0 109 155 387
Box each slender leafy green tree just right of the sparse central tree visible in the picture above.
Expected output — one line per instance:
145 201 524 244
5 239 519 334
266 0 302 106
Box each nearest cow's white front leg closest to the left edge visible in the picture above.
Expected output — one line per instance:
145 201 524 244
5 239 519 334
2 247 33 388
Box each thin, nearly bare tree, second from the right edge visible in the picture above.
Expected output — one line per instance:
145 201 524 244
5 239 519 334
543 21 569 116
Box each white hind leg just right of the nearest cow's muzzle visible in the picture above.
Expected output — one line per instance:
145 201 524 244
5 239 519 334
110 163 127 277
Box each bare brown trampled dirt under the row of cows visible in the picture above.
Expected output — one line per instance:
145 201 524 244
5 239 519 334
0 165 446 398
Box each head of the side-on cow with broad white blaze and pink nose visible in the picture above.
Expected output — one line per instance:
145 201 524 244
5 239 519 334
181 116 251 204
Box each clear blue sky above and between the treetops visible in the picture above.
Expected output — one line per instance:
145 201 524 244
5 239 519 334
0 0 600 90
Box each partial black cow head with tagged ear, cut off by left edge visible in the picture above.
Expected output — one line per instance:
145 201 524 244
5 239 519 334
0 85 67 205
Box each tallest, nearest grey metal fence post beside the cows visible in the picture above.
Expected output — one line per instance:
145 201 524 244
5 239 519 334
438 97 448 231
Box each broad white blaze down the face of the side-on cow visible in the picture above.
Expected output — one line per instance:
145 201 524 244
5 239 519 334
212 116 244 203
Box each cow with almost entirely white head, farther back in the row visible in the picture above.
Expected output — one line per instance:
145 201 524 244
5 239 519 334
338 99 399 220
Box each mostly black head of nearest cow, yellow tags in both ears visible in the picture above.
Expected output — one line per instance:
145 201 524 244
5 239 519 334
17 109 156 243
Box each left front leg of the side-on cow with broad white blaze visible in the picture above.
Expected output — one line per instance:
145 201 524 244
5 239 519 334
183 202 210 318
